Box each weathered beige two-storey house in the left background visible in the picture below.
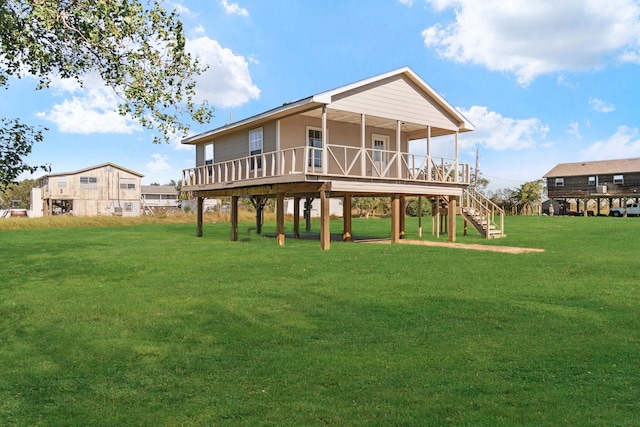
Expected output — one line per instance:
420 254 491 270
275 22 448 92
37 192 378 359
33 163 143 216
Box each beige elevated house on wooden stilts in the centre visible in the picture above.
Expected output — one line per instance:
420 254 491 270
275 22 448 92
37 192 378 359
182 67 503 249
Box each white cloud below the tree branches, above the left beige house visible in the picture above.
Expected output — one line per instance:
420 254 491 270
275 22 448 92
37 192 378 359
36 76 142 134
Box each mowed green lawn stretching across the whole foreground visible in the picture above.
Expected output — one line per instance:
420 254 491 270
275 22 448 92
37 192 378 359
0 217 640 426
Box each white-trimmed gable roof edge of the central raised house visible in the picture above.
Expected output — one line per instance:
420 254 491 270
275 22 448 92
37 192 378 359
182 67 474 144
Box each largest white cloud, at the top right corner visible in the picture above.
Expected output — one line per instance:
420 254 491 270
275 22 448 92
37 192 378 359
422 0 640 86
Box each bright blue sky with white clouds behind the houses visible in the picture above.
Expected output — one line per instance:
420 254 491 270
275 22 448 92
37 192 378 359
7 0 640 189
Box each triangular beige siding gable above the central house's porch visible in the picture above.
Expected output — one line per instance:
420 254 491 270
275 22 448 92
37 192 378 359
330 76 458 130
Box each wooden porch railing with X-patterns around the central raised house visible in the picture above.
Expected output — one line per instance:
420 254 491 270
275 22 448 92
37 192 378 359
182 145 470 186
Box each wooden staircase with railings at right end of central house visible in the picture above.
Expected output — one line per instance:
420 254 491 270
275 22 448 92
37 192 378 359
460 187 506 239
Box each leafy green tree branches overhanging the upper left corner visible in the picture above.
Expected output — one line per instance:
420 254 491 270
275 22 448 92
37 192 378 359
0 0 213 190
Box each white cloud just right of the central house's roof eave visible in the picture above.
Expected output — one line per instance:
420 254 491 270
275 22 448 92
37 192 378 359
459 106 549 151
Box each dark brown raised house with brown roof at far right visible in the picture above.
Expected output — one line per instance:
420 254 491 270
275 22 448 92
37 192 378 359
543 158 640 214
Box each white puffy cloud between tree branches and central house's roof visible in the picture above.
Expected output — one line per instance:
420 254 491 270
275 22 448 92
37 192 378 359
187 37 260 107
